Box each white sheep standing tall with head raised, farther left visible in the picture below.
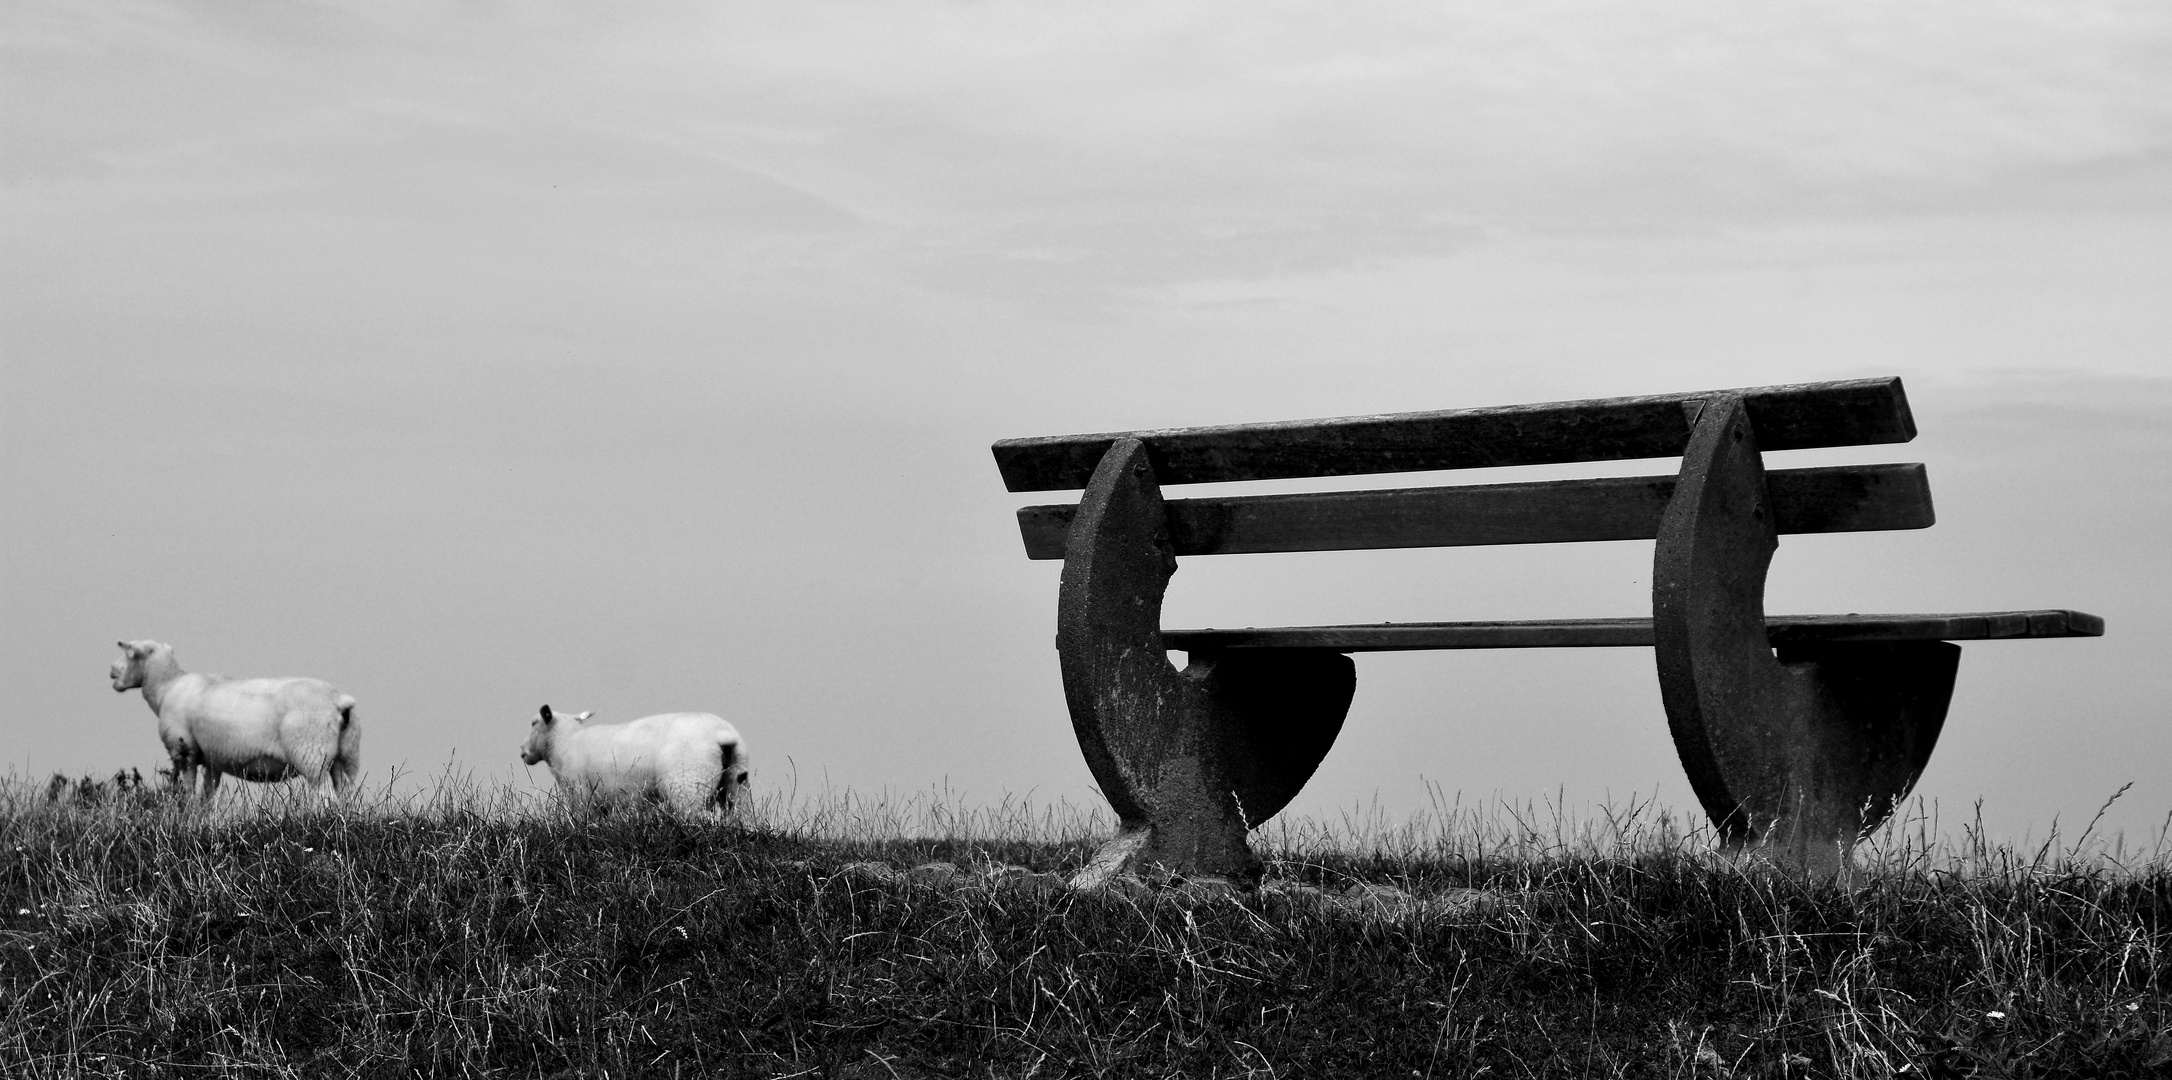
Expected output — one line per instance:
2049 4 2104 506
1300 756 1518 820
111 641 363 802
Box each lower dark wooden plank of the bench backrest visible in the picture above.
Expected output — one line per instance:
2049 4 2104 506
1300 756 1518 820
1019 465 1933 558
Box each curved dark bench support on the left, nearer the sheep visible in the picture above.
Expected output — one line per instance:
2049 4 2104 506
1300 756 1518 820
1056 439 1358 880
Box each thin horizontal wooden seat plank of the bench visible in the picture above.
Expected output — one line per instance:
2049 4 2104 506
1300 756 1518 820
1162 611 2105 652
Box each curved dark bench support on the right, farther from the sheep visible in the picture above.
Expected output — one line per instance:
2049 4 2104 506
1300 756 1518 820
1653 395 1961 874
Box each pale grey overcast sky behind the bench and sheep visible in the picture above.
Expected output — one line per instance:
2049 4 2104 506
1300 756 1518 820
0 0 2172 843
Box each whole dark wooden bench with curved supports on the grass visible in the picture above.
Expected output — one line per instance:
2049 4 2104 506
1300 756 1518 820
995 378 2105 880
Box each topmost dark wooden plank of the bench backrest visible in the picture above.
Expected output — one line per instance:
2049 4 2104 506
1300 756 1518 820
993 378 1916 491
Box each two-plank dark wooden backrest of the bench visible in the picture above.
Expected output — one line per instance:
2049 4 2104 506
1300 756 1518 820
995 378 1933 558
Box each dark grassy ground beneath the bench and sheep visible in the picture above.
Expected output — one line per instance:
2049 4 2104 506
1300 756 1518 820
0 782 2172 1078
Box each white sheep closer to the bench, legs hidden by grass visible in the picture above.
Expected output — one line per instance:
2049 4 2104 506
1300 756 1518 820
521 704 747 815
